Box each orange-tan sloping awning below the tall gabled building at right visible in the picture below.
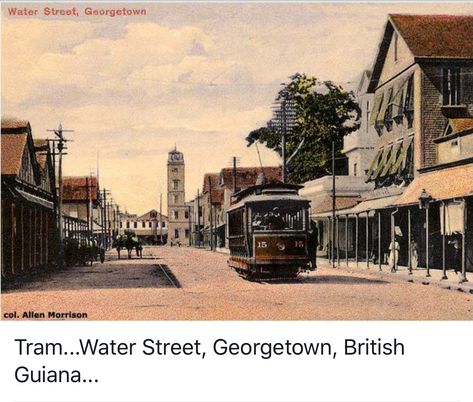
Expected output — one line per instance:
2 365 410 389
396 164 473 206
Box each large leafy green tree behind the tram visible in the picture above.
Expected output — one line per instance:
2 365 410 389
246 73 360 183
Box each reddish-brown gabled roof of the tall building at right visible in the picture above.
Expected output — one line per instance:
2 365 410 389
368 14 473 92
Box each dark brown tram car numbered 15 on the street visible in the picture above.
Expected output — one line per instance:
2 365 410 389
226 183 310 279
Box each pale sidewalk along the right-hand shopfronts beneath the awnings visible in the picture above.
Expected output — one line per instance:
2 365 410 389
317 258 473 294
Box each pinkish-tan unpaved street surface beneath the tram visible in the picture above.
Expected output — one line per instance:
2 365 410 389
2 247 473 320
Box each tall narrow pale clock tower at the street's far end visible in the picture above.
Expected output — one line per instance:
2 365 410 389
167 148 192 245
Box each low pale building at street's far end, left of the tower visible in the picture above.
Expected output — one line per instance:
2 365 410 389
119 209 168 244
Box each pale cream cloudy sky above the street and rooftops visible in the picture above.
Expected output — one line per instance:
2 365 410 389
1 2 473 214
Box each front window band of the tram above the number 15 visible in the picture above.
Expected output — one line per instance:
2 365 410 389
251 207 305 231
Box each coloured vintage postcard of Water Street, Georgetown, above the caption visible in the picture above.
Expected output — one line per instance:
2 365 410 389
1 2 473 320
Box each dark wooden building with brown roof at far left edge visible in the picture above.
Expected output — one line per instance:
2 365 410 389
1 119 57 277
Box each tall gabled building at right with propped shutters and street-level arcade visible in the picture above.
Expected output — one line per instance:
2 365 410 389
314 15 473 279
